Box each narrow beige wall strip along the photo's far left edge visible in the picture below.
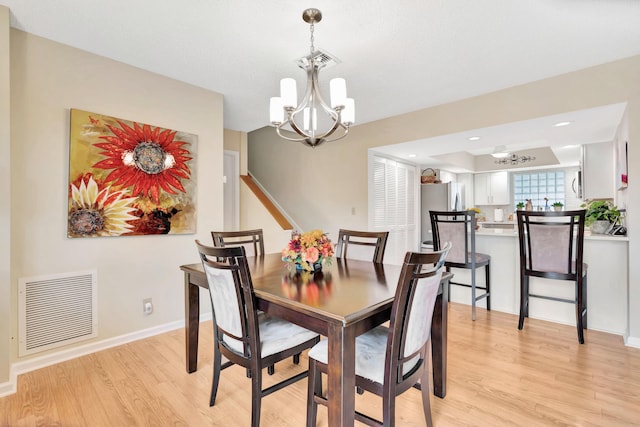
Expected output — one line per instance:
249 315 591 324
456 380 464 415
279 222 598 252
0 6 12 384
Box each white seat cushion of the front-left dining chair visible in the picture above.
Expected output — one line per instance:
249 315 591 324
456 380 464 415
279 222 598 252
223 312 318 357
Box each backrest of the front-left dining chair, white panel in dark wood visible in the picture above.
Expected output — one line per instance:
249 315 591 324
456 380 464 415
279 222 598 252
196 240 260 358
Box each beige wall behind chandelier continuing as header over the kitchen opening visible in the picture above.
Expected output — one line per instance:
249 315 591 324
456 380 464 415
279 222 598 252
248 56 640 347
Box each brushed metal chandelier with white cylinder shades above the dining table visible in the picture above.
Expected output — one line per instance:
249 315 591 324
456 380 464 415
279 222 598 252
269 9 355 147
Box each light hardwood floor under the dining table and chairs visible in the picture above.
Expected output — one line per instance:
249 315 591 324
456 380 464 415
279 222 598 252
0 303 640 427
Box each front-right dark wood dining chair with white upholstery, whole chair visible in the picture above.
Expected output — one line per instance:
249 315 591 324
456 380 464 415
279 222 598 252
307 245 450 427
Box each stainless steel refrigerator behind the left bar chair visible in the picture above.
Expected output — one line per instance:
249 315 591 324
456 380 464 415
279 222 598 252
420 182 465 249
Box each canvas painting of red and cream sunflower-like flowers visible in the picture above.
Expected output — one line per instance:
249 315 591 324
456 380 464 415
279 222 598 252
67 109 197 238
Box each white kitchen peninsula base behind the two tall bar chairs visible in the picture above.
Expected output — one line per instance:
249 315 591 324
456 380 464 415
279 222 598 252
450 228 629 335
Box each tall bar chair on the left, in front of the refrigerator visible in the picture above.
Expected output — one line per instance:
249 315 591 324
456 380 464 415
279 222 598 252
429 211 491 320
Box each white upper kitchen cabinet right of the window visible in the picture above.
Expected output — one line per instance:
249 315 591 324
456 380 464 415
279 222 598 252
581 142 615 200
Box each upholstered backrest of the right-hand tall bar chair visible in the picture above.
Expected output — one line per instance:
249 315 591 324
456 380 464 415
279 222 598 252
517 209 585 280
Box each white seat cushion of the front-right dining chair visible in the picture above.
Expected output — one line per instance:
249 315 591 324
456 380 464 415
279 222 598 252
309 326 419 384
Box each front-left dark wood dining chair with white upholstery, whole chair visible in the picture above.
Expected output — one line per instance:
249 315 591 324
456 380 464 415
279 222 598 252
196 240 320 427
